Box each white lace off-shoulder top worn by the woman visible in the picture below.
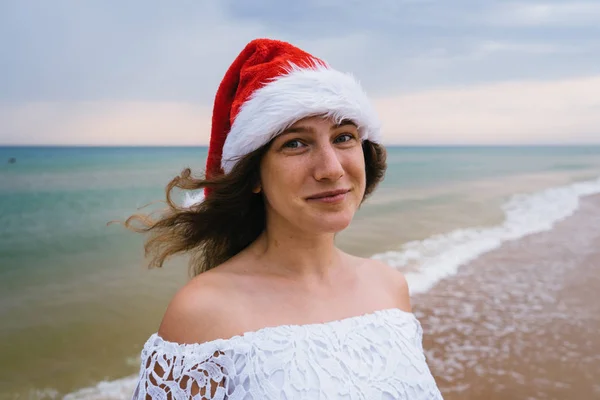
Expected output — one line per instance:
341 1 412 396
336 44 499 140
133 309 442 400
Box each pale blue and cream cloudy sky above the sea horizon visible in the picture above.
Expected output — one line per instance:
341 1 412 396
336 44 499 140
0 0 600 145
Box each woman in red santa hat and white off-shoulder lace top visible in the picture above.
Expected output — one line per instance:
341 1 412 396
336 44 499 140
127 39 441 400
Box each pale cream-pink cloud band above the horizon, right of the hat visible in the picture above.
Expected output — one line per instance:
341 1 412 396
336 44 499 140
377 75 600 144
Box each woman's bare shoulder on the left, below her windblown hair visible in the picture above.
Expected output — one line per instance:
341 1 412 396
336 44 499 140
158 271 247 343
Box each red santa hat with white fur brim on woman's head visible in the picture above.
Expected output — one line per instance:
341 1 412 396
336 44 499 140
184 39 380 207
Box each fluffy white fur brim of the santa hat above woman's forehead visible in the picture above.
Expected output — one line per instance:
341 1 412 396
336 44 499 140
221 64 381 173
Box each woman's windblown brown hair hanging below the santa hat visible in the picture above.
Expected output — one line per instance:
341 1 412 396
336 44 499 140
124 140 387 275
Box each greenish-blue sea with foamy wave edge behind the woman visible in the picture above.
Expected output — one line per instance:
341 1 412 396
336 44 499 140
0 145 600 399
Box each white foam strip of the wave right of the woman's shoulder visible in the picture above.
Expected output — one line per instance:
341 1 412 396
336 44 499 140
373 178 600 294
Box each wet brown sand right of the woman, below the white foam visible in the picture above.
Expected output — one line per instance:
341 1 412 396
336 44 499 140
413 195 600 400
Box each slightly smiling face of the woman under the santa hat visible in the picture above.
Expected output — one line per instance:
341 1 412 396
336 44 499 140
261 117 366 233
